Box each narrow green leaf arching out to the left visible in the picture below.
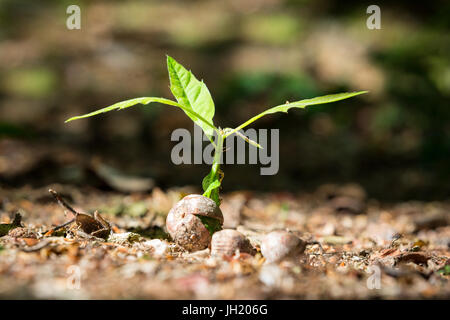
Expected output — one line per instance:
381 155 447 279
65 97 215 130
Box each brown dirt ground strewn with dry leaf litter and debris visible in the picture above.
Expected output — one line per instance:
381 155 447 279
0 185 450 299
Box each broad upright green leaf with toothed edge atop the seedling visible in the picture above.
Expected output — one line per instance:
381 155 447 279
167 56 214 139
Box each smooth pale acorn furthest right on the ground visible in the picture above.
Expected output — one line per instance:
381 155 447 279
261 231 306 263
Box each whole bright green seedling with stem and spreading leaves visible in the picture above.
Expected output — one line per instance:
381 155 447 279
66 56 367 205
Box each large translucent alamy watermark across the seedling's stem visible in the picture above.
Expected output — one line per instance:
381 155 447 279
171 125 280 176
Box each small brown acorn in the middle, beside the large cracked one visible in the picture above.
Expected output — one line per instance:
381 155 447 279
211 229 256 256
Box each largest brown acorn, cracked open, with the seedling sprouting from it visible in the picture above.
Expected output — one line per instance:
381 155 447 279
166 194 223 251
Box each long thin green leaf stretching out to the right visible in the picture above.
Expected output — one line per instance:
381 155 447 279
225 91 368 137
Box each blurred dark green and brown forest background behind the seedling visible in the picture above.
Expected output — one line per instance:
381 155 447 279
0 0 450 200
